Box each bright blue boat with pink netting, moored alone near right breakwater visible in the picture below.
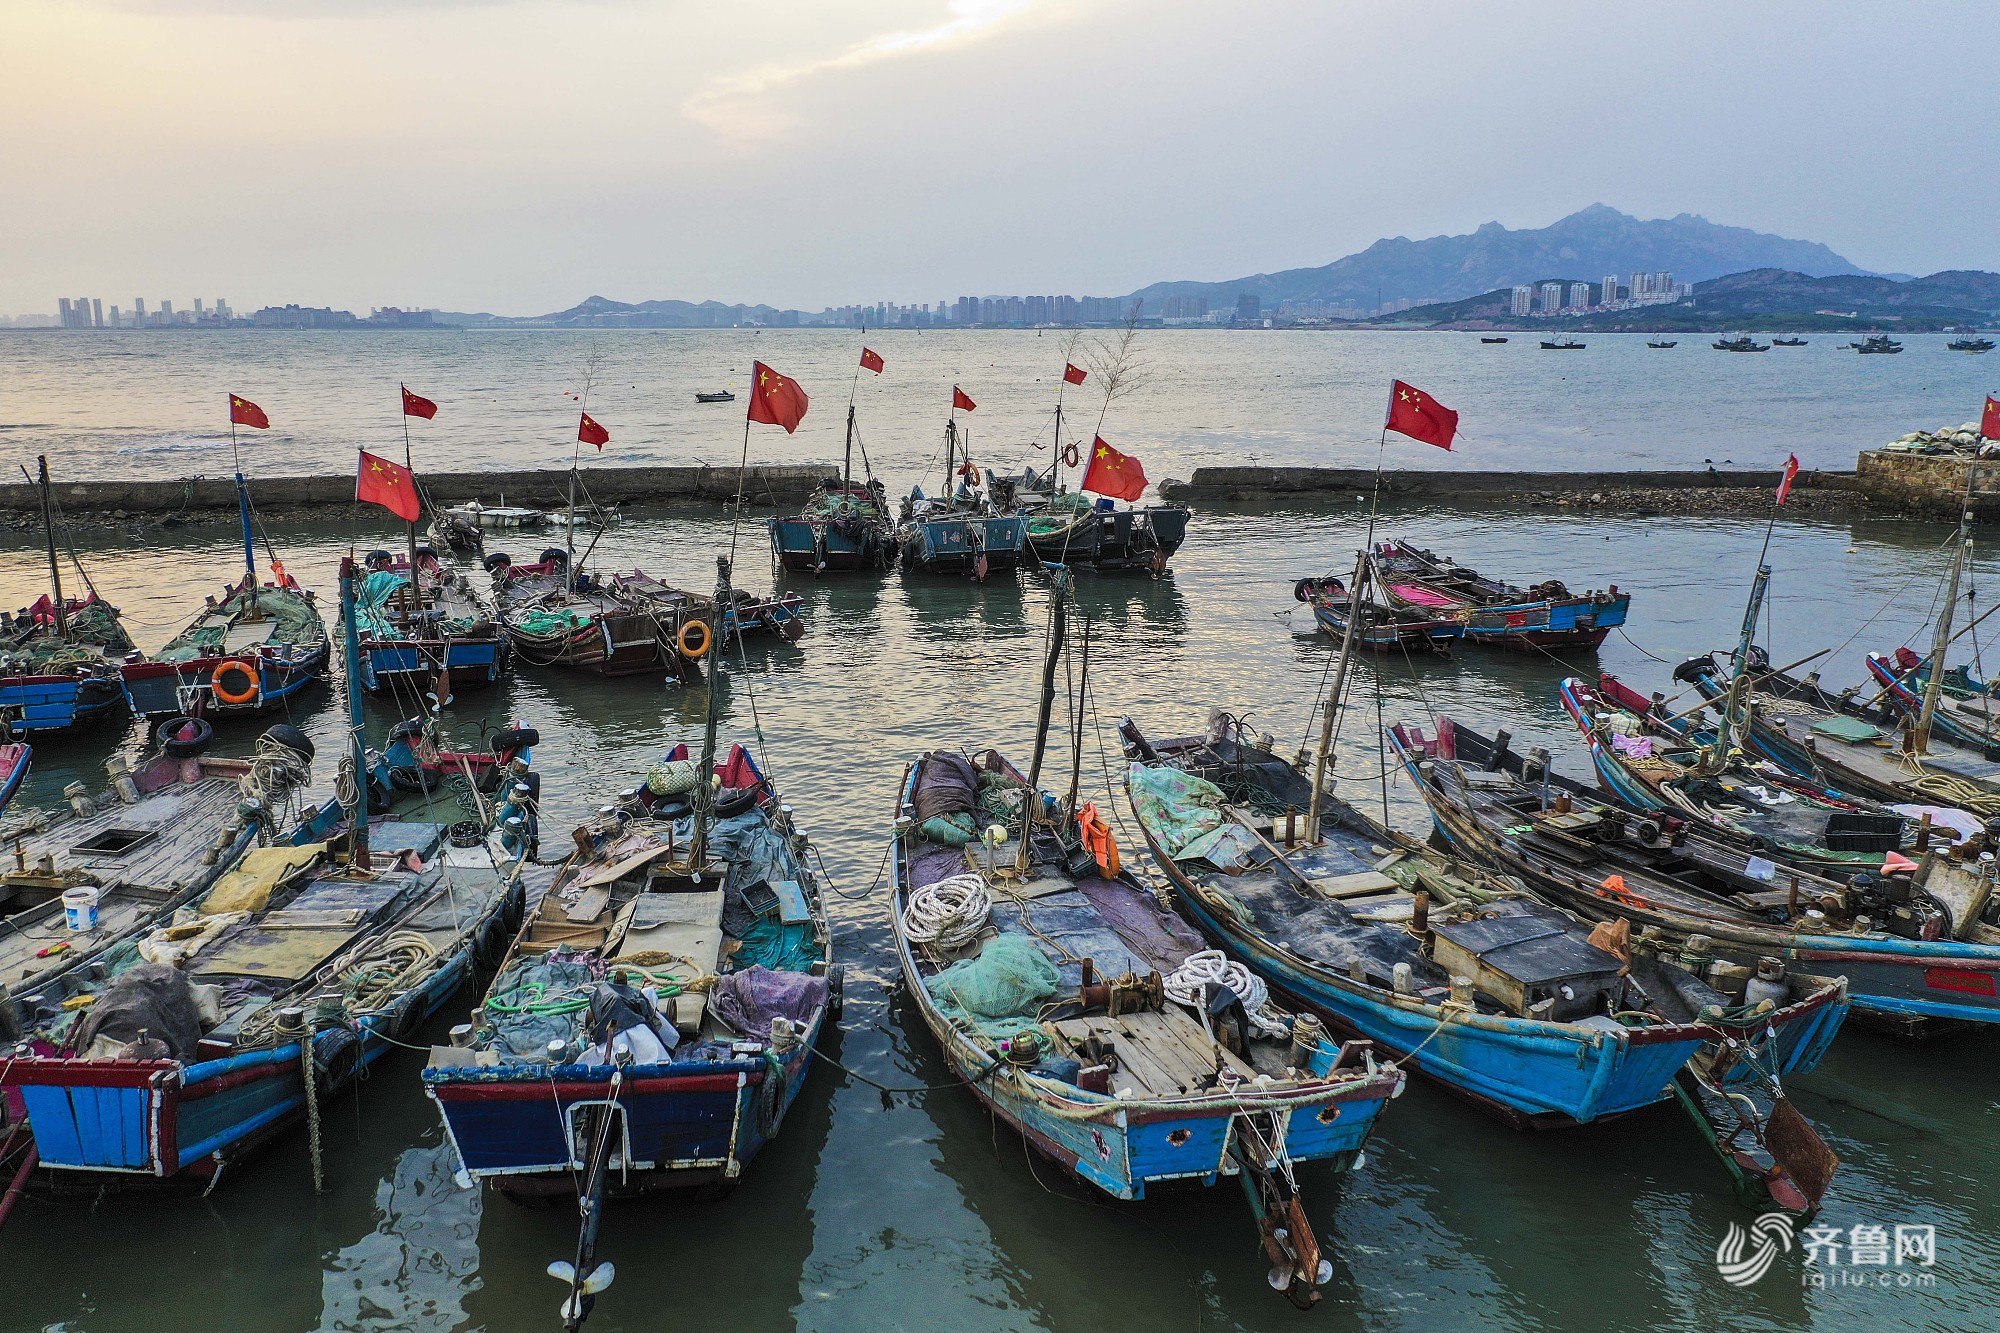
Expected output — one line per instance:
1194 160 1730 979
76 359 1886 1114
1374 540 1632 652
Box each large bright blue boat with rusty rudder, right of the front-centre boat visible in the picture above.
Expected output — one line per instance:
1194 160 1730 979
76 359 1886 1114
1120 713 1848 1213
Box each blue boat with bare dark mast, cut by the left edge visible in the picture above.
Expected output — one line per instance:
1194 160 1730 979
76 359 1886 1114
0 456 136 741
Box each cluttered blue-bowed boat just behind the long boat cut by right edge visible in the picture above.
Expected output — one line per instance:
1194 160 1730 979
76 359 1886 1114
1558 675 1916 879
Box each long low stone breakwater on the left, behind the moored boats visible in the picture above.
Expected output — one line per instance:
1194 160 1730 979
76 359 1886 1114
0 462 840 528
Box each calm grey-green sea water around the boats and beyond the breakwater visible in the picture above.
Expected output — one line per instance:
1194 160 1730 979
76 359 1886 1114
0 334 2000 1333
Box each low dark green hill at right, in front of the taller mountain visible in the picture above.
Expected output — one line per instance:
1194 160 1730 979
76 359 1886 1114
1374 268 2000 332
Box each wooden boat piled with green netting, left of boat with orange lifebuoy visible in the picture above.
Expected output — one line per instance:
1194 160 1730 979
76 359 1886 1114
486 546 674 677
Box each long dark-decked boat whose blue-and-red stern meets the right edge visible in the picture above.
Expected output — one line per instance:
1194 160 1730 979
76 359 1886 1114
1390 719 2000 1035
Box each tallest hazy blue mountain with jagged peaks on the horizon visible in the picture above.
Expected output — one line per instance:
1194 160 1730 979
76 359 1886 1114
1132 204 1866 314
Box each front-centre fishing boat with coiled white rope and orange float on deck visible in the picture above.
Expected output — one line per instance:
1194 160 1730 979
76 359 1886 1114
890 570 1402 1309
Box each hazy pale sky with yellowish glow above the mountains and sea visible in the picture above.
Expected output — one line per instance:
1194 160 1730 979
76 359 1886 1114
0 0 2000 314
